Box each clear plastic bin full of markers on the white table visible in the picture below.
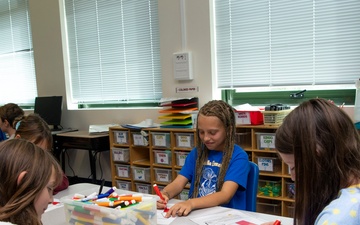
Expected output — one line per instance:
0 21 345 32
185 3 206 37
60 195 157 225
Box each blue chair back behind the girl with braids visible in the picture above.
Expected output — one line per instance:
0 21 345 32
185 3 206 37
246 162 259 212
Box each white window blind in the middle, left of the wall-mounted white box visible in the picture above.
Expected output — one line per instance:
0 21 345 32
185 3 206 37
64 0 162 104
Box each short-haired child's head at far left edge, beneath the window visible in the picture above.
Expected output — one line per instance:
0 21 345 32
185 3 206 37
0 103 24 139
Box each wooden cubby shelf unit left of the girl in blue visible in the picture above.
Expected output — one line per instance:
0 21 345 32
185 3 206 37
109 126 196 199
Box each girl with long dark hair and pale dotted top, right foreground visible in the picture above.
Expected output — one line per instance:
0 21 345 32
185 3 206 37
275 99 360 225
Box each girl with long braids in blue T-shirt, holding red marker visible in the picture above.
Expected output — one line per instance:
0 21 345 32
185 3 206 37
157 100 250 217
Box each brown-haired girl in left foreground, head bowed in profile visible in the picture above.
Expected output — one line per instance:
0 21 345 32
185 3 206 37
0 139 62 225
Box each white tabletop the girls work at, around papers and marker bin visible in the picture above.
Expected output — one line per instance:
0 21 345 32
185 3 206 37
42 183 293 225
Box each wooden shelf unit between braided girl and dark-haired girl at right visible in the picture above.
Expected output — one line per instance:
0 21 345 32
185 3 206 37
236 125 294 217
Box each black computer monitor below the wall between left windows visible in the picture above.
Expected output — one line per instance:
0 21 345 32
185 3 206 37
34 96 62 131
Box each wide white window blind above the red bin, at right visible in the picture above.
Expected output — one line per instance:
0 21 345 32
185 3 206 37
214 0 360 88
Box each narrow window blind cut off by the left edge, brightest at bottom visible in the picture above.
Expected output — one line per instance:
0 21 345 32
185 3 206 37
0 0 37 105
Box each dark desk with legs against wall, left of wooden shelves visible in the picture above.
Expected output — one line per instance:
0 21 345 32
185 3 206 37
54 131 110 183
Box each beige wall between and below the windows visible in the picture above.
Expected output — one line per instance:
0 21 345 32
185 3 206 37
29 0 214 180
